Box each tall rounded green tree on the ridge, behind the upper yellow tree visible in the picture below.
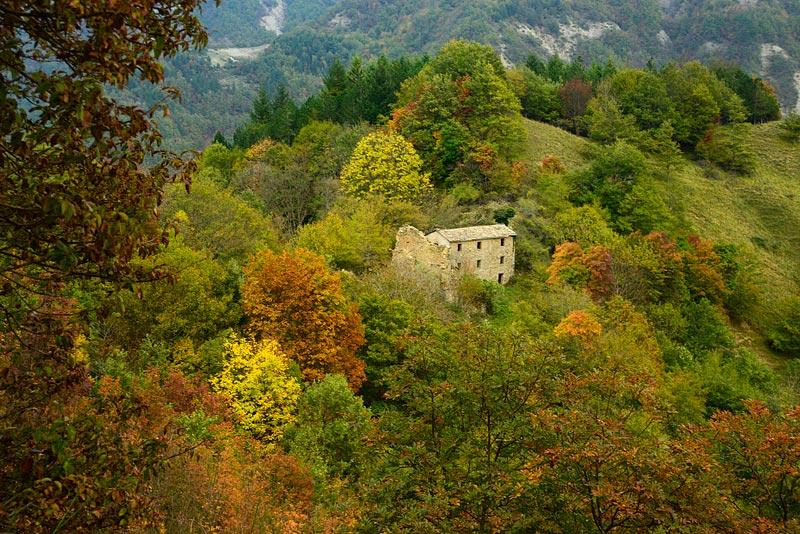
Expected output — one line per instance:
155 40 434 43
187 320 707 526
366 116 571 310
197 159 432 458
389 41 525 190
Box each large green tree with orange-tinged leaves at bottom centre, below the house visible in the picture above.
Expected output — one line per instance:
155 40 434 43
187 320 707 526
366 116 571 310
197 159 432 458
360 325 553 533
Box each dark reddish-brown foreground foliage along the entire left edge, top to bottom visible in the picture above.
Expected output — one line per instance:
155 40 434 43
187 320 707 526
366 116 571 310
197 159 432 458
0 0 214 532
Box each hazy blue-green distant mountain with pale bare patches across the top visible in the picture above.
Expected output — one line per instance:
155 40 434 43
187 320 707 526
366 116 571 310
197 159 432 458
152 0 800 146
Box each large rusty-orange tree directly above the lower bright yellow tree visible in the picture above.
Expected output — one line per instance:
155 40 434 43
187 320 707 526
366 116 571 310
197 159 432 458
242 248 365 390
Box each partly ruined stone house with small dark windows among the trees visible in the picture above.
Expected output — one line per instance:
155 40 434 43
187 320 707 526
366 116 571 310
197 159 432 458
392 224 517 295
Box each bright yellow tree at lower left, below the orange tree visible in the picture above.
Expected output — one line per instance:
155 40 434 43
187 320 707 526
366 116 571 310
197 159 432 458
211 337 301 442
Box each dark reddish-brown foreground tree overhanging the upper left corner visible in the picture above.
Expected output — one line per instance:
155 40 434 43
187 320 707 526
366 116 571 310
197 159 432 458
0 0 212 344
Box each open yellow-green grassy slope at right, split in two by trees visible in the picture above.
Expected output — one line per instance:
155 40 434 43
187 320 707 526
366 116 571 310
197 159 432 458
527 121 800 336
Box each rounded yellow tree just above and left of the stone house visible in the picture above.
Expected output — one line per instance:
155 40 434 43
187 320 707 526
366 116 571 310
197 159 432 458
341 132 431 202
